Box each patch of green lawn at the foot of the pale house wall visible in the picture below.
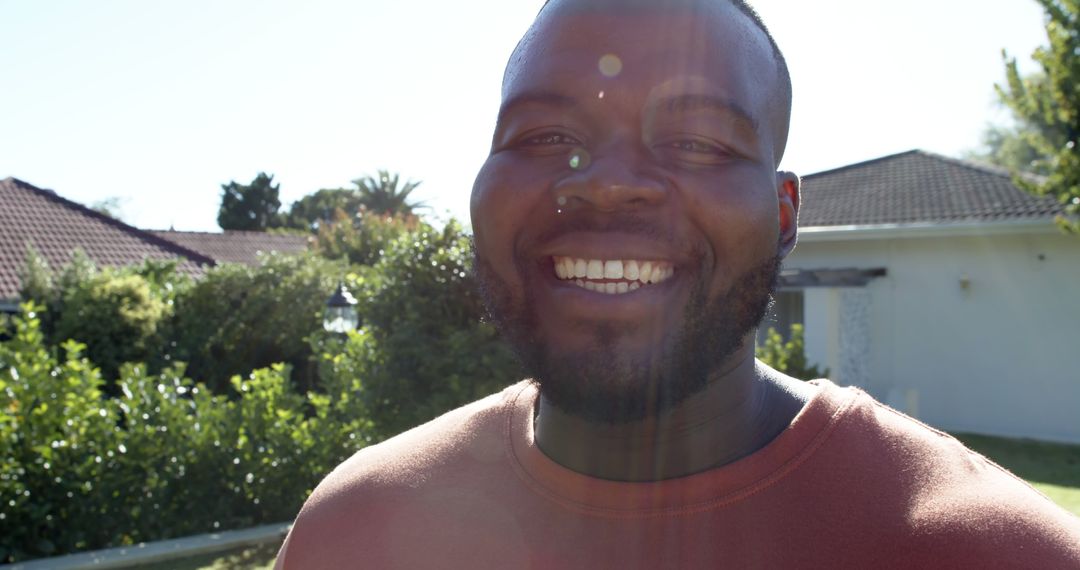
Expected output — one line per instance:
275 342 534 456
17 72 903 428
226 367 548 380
953 434 1080 516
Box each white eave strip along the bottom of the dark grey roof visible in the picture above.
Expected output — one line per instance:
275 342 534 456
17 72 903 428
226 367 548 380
799 217 1061 242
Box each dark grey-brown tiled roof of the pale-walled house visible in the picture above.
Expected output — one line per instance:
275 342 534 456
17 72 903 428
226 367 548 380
799 150 1063 227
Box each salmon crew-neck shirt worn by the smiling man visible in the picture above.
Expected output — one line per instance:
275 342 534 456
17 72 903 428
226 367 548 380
278 380 1080 570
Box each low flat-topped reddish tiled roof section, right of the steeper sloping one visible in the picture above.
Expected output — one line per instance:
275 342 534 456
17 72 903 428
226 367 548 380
150 230 308 266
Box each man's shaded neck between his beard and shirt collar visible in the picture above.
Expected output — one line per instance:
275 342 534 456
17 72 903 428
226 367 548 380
535 350 809 481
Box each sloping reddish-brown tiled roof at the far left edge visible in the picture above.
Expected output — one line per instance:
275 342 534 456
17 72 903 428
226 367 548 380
0 178 214 301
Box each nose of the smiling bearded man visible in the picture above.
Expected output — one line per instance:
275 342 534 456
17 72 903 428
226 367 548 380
554 148 666 212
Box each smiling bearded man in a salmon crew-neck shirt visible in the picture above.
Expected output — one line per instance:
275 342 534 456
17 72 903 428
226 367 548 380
278 0 1080 569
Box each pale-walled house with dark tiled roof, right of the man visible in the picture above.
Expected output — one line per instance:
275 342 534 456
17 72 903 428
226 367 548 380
767 150 1080 443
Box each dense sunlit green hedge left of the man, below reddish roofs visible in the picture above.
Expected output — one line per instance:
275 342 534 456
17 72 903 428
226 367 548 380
0 216 519 561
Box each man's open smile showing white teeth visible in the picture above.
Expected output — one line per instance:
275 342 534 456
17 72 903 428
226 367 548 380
552 256 675 295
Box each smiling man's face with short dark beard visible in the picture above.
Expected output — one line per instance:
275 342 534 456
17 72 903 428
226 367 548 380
472 2 797 422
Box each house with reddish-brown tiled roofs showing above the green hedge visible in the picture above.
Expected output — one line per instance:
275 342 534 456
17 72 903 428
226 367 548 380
0 178 308 312
